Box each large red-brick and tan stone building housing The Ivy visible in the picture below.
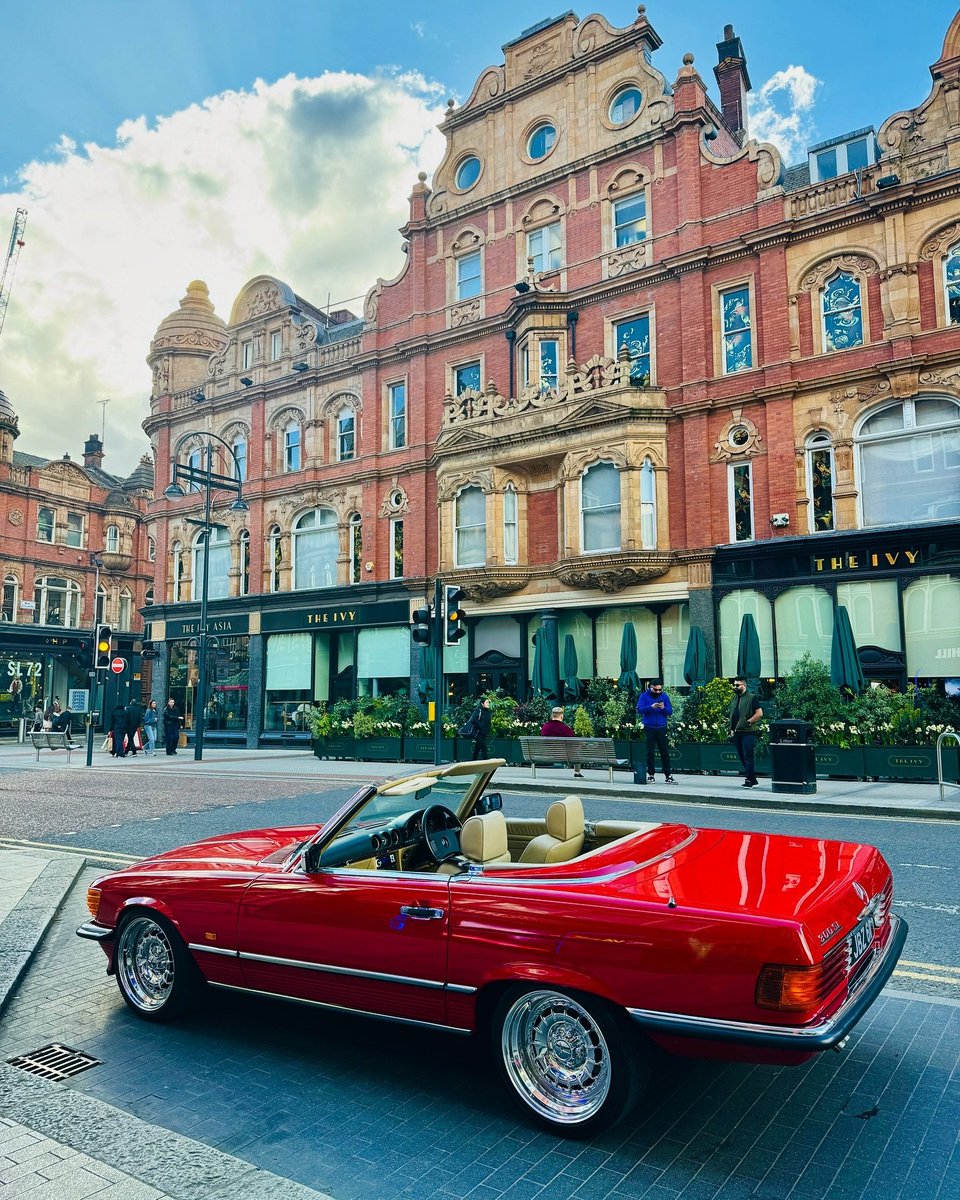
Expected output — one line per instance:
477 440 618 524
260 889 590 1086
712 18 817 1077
144 8 960 744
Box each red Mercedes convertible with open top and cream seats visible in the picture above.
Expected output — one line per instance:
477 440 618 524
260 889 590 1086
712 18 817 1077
78 761 906 1136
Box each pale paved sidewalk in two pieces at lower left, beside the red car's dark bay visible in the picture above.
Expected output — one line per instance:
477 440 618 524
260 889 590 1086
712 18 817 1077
0 850 330 1200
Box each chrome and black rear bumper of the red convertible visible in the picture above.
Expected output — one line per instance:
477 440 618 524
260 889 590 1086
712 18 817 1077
626 916 907 1051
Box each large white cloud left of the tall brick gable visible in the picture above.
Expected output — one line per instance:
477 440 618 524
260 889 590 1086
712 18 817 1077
0 73 445 474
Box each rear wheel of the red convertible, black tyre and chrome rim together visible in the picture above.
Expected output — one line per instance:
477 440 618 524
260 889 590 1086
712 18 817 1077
492 988 648 1138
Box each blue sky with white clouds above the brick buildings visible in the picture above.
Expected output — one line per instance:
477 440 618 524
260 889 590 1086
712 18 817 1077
0 0 955 470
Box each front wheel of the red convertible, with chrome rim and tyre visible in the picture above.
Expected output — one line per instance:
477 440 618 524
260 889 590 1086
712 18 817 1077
114 912 200 1021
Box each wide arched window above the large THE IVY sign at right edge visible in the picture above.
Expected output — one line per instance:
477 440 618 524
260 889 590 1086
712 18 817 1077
857 396 960 526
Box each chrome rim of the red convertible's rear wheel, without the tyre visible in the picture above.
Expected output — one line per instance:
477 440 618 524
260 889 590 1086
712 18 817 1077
500 991 612 1126
